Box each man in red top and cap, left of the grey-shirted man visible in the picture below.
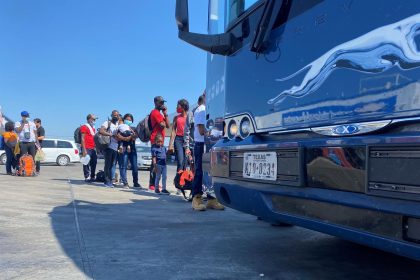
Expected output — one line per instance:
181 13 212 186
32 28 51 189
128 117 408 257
80 114 98 183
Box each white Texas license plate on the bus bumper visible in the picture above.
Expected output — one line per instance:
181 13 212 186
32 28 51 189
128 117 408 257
243 152 277 181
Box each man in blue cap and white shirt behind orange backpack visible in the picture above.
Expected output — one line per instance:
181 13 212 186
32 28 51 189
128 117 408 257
15 111 39 162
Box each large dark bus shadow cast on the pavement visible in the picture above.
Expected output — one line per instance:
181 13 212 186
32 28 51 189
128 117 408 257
50 188 420 280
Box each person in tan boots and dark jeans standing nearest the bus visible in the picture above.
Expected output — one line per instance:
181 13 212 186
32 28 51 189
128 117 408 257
186 94 225 211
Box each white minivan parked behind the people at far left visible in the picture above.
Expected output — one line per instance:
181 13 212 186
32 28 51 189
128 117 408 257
0 139 80 166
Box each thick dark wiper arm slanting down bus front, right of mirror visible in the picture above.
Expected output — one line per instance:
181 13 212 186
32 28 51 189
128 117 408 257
251 0 287 53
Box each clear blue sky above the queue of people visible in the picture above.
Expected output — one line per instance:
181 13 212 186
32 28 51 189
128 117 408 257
0 0 208 139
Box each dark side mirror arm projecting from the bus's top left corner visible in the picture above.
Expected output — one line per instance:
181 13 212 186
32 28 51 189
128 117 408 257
175 0 239 56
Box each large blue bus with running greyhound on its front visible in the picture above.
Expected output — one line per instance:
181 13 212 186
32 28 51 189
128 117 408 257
176 0 420 260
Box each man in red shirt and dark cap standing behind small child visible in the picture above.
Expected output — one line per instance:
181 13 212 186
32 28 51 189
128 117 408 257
149 96 170 191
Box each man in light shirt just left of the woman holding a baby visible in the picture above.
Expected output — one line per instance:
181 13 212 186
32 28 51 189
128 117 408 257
99 110 131 188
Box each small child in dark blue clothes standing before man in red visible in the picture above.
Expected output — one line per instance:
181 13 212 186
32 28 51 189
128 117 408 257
152 134 170 195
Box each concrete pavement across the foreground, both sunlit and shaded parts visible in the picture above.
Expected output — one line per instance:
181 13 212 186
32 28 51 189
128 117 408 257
0 160 420 280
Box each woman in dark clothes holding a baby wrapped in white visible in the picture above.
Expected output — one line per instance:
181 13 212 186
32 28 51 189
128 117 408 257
118 113 142 189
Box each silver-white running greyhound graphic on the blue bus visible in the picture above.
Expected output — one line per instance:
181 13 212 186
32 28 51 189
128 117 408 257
268 14 420 104
